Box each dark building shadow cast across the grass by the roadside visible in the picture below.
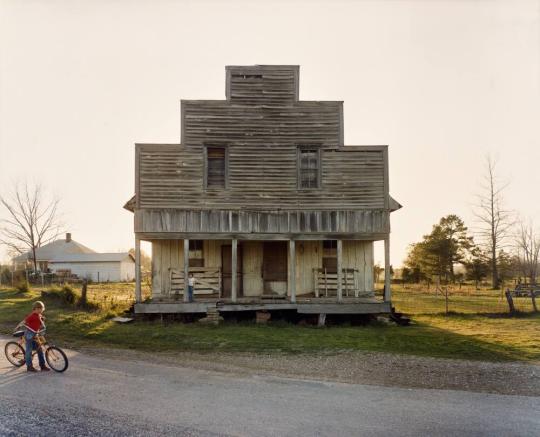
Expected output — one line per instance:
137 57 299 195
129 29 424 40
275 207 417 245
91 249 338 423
50 317 530 361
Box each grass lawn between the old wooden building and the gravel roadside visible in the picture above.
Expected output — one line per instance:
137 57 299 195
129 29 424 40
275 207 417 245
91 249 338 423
0 285 540 362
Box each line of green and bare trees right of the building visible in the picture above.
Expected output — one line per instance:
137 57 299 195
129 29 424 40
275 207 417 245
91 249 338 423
402 157 540 289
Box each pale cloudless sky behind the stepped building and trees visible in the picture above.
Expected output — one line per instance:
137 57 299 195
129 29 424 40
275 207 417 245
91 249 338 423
0 0 540 266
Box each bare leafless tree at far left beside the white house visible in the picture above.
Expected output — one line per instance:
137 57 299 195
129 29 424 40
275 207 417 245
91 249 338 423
0 182 62 271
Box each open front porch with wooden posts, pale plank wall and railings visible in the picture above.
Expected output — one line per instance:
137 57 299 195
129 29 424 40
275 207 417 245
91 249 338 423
135 237 390 314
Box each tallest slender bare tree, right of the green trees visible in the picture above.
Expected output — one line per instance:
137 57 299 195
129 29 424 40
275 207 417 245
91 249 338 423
474 156 514 289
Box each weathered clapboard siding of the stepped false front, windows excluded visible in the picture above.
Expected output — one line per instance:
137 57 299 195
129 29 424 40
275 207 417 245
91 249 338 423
135 65 389 214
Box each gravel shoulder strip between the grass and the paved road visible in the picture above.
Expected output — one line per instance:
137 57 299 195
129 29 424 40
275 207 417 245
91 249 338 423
77 348 540 396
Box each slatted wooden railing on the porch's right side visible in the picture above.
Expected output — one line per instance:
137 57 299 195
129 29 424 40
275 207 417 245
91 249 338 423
313 269 373 297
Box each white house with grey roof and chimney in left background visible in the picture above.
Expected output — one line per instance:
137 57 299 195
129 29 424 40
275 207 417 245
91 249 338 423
13 233 135 282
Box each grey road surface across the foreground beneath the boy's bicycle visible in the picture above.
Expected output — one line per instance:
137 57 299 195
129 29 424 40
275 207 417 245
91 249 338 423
0 338 540 436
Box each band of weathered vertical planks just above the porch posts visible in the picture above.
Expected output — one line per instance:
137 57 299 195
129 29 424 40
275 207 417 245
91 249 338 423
135 209 390 235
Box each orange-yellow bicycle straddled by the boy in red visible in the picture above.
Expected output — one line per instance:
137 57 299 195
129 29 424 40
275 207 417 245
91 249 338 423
4 328 69 373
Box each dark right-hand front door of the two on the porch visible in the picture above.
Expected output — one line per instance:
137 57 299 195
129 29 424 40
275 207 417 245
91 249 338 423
263 241 287 295
